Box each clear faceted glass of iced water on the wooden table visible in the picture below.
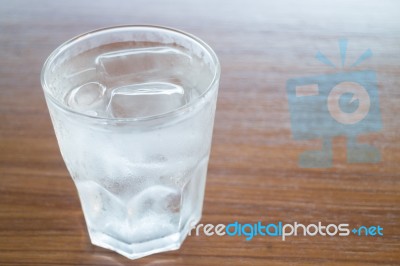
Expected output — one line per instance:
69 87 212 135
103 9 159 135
41 26 220 259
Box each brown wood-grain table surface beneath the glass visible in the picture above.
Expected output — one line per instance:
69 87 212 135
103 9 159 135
0 0 400 266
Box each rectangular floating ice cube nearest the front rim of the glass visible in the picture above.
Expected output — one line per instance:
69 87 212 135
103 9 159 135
106 82 187 118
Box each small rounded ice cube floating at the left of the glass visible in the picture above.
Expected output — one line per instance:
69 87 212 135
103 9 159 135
65 82 106 115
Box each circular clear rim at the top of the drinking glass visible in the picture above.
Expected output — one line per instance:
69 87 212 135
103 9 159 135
40 25 221 122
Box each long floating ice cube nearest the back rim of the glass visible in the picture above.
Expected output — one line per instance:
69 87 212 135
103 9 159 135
95 47 192 88
